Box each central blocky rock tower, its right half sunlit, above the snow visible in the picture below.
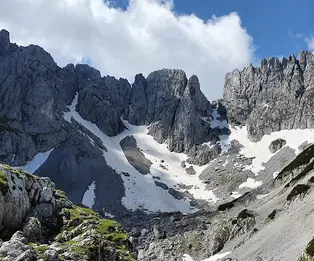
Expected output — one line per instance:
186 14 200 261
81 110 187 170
128 69 212 152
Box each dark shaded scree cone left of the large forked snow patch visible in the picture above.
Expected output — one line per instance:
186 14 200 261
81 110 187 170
35 134 127 215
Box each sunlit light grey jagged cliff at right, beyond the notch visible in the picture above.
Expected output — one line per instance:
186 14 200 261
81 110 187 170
223 51 314 141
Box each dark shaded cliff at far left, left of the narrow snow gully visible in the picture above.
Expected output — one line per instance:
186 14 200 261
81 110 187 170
0 31 71 165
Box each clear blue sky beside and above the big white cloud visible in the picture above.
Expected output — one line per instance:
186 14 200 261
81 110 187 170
111 0 314 60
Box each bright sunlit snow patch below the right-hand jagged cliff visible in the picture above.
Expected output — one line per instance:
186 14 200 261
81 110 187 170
222 127 314 175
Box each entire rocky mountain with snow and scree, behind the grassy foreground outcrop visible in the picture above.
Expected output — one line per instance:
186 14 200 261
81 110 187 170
0 27 314 261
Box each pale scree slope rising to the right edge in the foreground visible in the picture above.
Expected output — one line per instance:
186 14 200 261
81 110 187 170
133 145 314 261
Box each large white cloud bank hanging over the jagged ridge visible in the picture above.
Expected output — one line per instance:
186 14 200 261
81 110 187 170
0 0 254 99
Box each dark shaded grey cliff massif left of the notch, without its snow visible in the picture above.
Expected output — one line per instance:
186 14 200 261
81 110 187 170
0 30 217 215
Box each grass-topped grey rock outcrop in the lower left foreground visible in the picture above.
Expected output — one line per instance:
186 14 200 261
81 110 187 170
0 165 135 261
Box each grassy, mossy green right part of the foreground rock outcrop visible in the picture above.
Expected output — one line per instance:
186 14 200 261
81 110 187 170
55 205 134 261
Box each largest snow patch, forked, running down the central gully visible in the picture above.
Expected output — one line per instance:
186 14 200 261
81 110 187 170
63 94 218 213
